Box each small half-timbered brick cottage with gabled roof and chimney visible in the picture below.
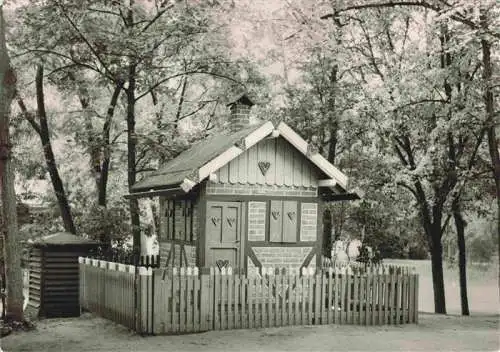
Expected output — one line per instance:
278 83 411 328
128 95 359 273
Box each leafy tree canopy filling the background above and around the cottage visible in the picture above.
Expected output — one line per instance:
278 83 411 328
2 0 500 316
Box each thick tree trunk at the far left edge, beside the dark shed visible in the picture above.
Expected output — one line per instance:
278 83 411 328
0 5 24 321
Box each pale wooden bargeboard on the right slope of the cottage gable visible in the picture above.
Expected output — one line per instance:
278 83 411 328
277 122 349 189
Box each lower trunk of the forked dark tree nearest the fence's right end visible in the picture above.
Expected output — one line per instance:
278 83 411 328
430 224 446 314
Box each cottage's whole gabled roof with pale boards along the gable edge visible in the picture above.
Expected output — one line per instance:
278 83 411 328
130 122 356 196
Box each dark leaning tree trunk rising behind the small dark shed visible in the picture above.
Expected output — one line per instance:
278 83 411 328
36 65 76 234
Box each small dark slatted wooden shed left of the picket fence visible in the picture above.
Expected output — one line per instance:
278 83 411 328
28 232 98 318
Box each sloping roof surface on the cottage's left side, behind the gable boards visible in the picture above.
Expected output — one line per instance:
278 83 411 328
132 124 264 192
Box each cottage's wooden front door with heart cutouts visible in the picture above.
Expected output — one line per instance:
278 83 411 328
205 202 244 268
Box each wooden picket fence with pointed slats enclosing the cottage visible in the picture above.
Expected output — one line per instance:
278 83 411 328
80 258 418 334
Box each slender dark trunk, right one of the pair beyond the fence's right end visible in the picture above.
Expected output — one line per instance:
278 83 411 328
452 199 470 315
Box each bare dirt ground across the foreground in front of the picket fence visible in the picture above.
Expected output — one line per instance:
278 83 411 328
0 314 500 352
